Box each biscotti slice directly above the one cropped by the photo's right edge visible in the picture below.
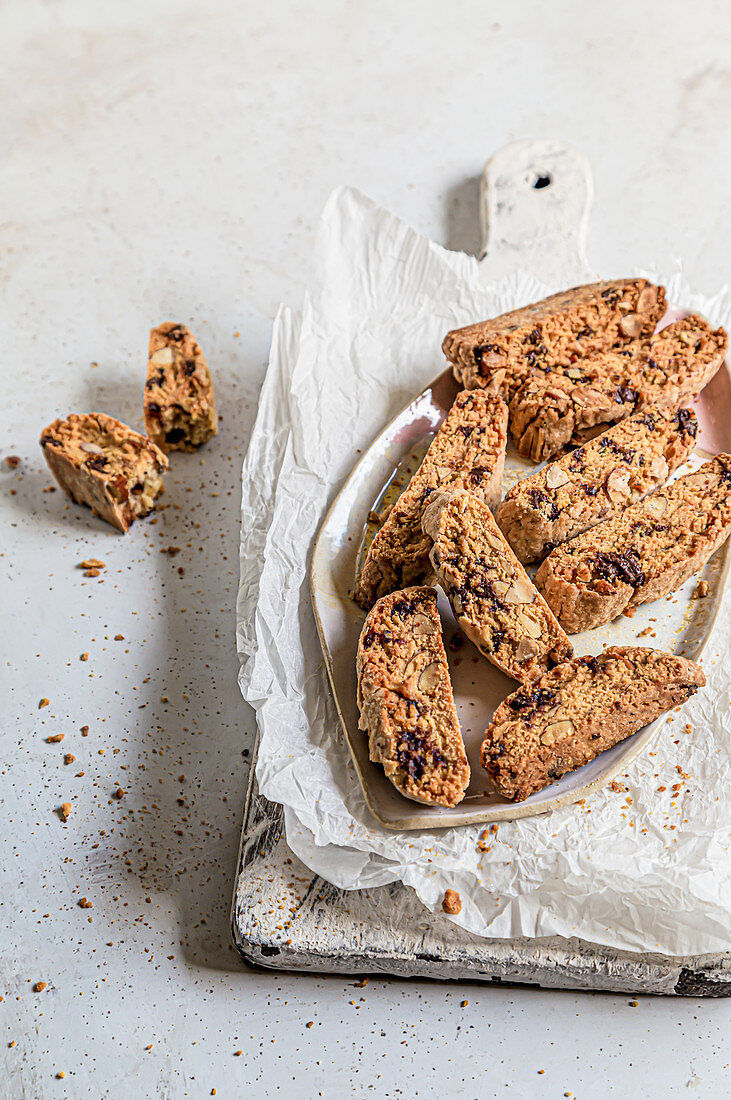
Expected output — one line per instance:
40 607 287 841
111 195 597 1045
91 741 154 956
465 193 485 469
495 409 698 562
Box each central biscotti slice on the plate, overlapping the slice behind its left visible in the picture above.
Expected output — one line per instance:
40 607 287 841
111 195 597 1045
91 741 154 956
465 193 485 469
422 492 573 683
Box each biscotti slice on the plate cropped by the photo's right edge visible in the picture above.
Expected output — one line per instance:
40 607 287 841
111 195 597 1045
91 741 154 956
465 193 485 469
535 454 731 634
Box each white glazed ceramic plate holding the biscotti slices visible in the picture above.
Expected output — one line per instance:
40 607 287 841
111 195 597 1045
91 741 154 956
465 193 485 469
310 332 731 829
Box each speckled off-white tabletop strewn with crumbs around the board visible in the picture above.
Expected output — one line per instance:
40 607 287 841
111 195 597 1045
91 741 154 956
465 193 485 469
0 0 731 1100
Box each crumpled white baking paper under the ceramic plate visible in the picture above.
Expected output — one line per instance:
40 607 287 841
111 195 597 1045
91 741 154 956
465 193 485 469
237 188 731 955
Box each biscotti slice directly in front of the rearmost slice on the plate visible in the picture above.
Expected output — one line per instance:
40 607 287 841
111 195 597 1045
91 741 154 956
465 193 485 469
510 314 728 462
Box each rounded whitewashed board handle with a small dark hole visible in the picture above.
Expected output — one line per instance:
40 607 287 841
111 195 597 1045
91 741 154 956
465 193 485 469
479 140 595 287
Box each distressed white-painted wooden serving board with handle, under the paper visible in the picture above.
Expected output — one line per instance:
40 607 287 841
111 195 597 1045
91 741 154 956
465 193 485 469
232 141 731 997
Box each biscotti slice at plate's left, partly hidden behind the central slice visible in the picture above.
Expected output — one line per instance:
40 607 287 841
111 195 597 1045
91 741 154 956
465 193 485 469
355 391 508 609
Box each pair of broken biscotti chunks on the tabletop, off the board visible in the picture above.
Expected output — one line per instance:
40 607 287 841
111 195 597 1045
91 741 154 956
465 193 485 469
41 321 218 532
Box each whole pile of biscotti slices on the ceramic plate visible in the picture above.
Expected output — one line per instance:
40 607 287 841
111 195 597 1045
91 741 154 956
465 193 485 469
355 278 731 806
